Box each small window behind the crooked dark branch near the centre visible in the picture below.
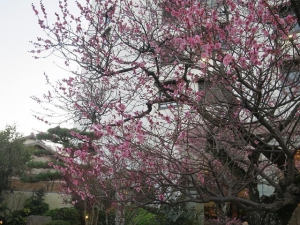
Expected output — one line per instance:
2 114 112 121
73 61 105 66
158 80 179 109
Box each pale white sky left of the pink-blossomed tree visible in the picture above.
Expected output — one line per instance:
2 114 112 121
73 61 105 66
0 0 79 135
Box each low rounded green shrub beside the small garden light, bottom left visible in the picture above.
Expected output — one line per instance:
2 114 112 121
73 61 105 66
44 207 81 225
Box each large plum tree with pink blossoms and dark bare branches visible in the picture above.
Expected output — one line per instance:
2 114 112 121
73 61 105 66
32 0 300 224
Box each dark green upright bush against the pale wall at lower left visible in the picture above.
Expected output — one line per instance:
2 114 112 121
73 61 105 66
24 189 49 215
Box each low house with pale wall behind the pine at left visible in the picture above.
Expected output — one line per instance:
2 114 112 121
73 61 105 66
4 133 71 211
